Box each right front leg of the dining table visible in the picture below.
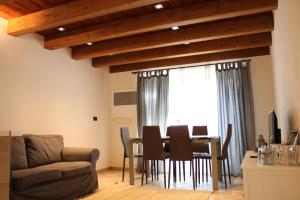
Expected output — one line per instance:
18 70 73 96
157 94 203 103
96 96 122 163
211 140 219 190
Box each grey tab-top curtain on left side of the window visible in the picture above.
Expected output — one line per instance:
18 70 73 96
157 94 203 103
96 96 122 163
137 70 169 171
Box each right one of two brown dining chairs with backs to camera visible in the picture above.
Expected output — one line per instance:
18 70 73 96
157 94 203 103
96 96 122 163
168 126 197 190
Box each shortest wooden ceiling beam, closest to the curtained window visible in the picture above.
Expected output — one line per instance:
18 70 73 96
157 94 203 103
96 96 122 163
109 47 270 73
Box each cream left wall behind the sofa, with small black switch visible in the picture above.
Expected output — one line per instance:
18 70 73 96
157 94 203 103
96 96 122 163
0 18 110 169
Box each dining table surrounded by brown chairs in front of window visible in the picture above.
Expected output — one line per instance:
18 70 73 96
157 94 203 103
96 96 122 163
128 135 222 190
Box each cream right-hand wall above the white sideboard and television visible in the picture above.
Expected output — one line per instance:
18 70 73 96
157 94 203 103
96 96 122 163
272 0 300 138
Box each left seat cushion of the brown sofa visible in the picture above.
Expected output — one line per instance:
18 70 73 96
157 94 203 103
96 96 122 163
11 168 61 190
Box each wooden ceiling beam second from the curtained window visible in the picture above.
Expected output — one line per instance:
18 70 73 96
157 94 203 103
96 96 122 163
92 32 272 67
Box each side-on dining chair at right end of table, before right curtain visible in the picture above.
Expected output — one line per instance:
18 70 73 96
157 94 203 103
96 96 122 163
200 124 232 189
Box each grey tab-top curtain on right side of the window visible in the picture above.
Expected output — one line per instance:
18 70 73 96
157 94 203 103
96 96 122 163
216 61 255 176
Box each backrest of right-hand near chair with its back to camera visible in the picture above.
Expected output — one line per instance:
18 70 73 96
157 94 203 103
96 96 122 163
169 126 193 161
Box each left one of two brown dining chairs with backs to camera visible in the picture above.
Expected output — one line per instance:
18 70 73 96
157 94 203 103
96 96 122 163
141 126 166 188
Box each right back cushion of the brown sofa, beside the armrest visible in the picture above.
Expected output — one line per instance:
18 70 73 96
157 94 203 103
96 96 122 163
24 135 64 168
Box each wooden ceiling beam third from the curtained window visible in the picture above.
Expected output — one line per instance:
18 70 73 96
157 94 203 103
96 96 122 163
72 13 274 59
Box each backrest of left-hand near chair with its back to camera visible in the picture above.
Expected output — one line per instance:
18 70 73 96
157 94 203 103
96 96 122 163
142 126 165 160
